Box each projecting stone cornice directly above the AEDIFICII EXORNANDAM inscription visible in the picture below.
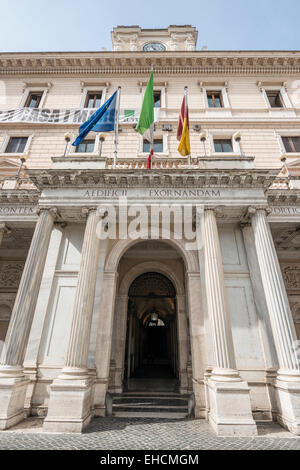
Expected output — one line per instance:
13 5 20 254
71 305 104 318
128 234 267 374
28 169 278 191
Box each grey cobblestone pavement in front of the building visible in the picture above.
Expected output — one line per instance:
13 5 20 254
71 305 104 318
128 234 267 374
0 417 300 450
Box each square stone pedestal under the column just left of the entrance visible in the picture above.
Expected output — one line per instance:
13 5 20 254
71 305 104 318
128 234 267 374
43 370 93 433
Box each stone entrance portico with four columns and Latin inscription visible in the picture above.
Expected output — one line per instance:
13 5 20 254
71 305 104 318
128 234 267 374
0 157 299 435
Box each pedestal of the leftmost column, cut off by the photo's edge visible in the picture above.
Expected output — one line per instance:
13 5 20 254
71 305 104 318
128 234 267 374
0 366 29 430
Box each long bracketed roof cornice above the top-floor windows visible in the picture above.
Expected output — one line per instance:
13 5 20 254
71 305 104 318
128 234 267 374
0 51 300 76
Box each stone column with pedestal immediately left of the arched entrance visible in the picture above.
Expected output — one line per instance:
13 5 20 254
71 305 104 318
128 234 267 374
44 208 100 432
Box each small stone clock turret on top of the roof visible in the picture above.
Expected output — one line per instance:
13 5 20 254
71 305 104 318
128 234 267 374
111 25 198 52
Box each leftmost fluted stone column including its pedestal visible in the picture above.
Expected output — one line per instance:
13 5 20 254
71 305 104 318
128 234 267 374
0 209 56 429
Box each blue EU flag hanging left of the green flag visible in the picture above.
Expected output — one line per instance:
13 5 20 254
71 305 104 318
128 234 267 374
72 90 118 147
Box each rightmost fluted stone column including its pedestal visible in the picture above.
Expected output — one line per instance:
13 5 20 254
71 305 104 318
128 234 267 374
249 208 300 434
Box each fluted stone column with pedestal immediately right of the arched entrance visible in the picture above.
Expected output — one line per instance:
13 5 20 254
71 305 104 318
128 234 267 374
203 209 257 436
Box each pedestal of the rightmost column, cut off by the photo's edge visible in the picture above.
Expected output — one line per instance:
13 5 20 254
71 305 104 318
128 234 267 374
275 371 300 436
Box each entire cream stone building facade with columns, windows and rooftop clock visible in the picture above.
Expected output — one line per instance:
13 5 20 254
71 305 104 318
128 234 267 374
0 25 300 435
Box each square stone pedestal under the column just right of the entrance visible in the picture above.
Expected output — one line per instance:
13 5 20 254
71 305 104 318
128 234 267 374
207 377 257 436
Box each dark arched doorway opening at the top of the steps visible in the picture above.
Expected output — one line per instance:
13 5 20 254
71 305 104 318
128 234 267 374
124 272 178 390
